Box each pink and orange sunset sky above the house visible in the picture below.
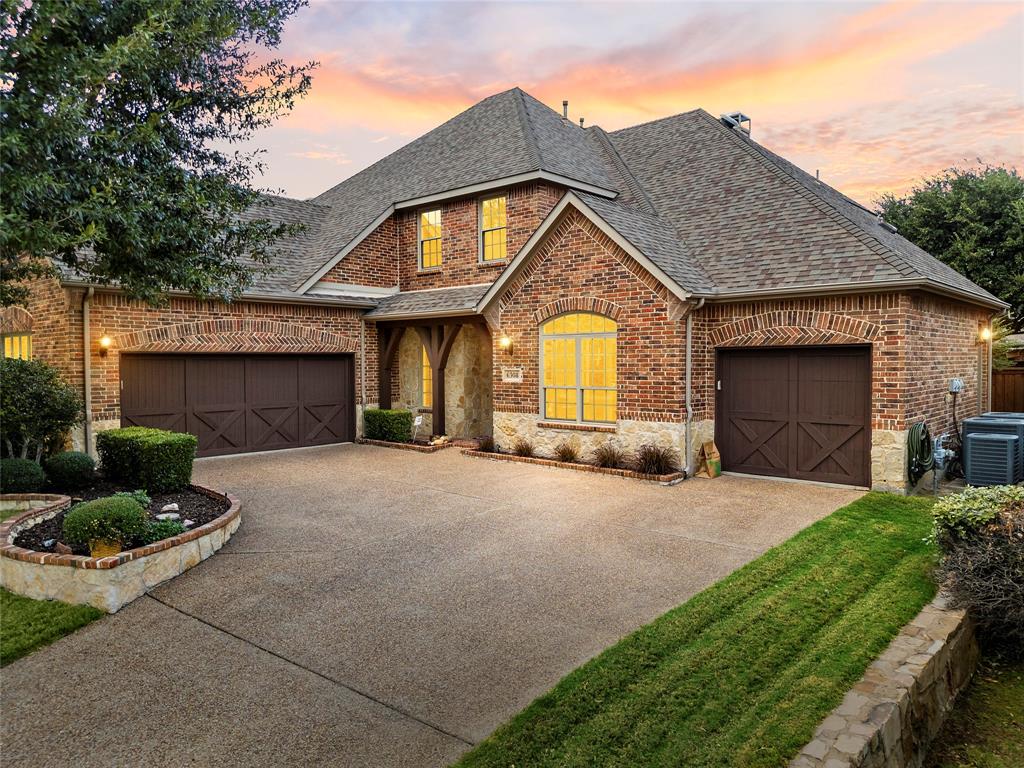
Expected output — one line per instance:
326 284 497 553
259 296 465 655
247 0 1024 204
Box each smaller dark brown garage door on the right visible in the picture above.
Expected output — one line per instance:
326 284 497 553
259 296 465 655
715 347 871 485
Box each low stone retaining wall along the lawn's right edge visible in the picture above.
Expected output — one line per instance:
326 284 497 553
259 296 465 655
790 596 978 768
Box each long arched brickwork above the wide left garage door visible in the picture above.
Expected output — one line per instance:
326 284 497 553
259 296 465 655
115 318 357 352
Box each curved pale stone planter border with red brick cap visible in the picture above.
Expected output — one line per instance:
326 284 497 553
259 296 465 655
0 485 242 613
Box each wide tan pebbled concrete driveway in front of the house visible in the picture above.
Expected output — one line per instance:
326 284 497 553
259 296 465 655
2 445 860 768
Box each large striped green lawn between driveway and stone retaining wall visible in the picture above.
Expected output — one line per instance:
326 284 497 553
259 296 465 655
459 494 935 766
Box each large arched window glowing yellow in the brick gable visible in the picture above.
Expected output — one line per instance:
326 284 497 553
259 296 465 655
541 312 618 423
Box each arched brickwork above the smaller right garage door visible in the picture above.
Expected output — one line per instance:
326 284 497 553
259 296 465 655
710 310 880 347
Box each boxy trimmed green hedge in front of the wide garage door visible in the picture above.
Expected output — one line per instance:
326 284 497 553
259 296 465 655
96 427 198 494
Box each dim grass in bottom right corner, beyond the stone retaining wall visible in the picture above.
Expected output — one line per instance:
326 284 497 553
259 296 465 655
925 657 1024 768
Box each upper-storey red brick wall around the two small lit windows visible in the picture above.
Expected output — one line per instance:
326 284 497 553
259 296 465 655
396 183 562 291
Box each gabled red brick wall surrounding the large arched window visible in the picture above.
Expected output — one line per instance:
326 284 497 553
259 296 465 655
494 207 684 422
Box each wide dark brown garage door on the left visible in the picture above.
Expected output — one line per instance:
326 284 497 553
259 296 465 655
121 354 355 456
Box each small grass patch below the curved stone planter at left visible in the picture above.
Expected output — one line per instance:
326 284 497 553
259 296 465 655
0 589 103 667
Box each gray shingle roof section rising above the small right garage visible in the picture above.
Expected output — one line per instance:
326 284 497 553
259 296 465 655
610 110 997 301
